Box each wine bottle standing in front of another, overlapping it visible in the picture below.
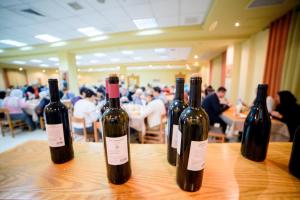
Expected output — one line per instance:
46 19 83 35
176 74 209 192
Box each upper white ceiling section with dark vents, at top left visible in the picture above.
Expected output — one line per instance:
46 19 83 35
0 0 212 48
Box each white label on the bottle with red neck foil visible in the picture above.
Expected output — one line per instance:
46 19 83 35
105 135 128 165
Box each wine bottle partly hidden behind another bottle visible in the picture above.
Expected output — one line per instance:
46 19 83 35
167 78 187 166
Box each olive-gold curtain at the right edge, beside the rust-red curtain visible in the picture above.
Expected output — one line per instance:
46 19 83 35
281 7 300 102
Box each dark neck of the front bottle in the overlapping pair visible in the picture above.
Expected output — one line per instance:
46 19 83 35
189 80 201 108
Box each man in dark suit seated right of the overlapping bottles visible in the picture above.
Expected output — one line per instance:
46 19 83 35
202 87 229 133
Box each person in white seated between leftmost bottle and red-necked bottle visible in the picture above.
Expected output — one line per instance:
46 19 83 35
73 89 99 140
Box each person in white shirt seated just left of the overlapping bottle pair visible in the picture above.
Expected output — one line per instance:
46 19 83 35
141 93 166 130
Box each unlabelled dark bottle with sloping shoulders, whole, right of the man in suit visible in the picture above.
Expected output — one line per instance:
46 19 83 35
241 84 271 162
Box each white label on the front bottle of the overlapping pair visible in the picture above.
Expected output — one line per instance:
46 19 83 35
187 140 208 171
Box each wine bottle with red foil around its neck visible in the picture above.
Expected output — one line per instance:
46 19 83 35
102 75 131 184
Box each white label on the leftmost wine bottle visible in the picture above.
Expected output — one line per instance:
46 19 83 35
46 124 65 147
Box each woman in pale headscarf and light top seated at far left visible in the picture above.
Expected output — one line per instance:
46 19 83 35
3 89 35 130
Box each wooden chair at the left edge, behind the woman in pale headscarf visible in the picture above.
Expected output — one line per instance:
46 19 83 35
0 108 31 137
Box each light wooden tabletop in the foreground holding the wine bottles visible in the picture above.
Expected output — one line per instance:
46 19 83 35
0 141 300 200
